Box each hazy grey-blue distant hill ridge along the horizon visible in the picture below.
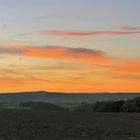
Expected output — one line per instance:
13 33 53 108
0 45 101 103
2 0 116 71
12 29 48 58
0 91 140 106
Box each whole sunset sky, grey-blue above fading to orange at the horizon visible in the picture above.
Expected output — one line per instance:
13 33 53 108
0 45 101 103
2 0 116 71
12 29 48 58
0 0 140 93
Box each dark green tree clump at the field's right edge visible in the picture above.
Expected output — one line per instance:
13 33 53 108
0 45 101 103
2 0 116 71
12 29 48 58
74 97 140 112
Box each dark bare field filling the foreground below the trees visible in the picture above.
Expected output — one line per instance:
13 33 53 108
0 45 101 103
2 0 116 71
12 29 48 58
0 111 140 140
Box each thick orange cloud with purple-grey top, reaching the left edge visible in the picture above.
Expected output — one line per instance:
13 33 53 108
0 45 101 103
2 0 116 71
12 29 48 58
0 46 111 64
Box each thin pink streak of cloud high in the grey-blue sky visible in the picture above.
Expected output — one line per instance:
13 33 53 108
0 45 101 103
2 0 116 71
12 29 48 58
18 26 140 37
